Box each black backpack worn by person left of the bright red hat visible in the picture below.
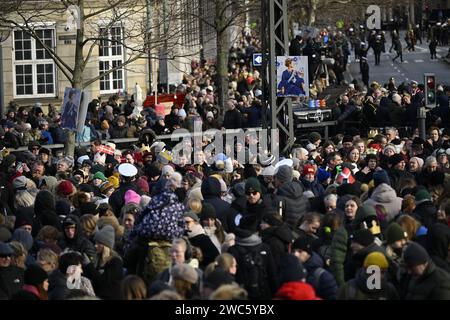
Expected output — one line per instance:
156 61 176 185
238 245 270 299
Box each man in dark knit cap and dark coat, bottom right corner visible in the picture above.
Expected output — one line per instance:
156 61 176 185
403 242 450 300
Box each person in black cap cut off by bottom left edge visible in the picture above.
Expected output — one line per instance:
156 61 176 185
0 242 24 300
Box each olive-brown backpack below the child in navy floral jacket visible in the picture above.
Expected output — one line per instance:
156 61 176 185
142 240 172 284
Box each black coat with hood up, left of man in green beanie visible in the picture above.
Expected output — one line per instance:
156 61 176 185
201 177 230 232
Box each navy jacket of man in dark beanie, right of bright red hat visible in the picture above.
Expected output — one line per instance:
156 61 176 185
303 252 338 300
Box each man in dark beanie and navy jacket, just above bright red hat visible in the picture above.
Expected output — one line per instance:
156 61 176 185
292 237 338 300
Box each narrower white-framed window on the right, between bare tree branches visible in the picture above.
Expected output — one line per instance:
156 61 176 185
98 27 124 94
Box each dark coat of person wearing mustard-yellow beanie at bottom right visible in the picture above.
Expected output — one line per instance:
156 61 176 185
338 268 399 300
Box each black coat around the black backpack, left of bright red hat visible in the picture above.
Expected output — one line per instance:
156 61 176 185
228 233 277 299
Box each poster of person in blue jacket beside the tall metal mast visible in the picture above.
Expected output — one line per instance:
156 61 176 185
276 56 309 97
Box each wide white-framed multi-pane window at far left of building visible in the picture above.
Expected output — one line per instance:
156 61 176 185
13 29 56 98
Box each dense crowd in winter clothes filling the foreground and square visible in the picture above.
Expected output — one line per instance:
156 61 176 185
0 26 450 300
